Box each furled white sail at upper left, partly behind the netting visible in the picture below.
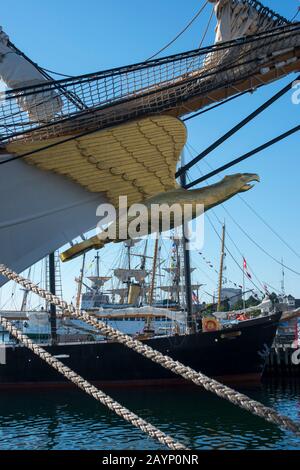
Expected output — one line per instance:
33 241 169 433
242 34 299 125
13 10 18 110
0 26 62 122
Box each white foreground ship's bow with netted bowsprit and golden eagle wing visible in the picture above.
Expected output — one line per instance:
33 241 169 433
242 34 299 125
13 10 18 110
0 0 300 284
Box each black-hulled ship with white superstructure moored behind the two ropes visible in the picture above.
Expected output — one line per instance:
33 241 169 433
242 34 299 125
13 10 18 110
0 227 296 388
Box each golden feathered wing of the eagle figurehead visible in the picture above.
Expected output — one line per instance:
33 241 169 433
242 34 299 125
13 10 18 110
6 115 187 207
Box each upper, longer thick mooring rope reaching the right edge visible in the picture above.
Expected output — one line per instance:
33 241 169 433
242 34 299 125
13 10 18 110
0 265 300 436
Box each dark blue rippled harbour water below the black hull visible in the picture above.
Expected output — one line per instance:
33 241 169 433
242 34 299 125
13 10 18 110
0 382 300 450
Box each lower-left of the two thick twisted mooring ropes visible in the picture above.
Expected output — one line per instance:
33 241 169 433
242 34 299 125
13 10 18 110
0 316 187 450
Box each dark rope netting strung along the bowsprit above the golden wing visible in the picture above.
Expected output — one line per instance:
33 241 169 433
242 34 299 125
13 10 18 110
0 23 300 145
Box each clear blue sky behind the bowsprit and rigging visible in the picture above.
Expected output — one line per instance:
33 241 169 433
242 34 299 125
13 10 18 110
1 0 300 304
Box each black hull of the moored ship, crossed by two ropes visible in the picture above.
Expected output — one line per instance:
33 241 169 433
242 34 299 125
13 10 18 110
0 313 281 387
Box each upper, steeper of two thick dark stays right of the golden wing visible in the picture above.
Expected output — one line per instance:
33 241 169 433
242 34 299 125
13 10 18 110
176 75 300 178
